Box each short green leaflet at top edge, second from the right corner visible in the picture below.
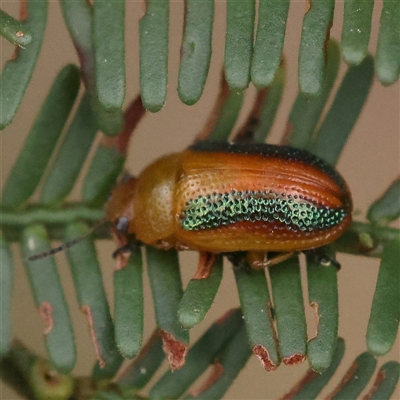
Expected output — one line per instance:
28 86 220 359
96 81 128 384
341 0 374 65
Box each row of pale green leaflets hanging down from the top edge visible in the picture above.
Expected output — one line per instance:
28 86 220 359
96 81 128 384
0 0 400 128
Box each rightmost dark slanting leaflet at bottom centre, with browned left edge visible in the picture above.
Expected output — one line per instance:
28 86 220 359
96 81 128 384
184 326 251 400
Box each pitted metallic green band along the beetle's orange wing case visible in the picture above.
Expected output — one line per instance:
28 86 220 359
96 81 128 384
181 191 347 232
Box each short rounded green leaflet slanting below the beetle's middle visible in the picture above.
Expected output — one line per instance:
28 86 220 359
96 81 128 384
178 256 223 329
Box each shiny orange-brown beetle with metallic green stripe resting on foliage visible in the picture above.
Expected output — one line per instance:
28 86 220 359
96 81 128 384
106 141 352 268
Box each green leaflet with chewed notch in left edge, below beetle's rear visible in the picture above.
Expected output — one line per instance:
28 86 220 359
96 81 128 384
307 260 339 373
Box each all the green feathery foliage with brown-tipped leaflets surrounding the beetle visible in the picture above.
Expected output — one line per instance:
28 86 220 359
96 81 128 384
0 0 400 399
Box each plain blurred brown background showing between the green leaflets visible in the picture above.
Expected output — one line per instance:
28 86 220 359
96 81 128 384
0 0 400 399
